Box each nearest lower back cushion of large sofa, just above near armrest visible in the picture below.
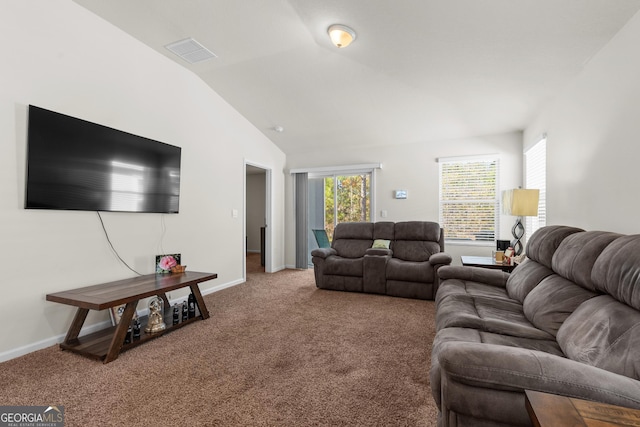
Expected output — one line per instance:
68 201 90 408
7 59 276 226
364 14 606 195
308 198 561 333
557 295 640 380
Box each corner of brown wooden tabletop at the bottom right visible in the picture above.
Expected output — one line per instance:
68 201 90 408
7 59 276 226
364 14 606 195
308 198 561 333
525 390 640 427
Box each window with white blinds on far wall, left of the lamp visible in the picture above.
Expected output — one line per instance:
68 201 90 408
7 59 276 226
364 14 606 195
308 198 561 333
438 156 500 243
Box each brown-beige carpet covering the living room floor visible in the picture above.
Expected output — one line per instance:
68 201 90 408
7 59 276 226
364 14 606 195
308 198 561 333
0 255 437 426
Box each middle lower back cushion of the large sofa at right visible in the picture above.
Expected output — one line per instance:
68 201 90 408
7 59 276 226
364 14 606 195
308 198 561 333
523 274 596 336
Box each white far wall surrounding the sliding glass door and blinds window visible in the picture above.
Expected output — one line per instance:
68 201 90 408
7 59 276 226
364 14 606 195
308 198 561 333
286 132 522 266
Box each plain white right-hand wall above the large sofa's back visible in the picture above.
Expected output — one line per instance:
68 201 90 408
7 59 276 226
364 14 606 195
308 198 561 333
524 10 640 234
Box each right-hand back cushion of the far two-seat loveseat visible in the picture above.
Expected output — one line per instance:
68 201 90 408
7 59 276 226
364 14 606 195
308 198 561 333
391 221 440 262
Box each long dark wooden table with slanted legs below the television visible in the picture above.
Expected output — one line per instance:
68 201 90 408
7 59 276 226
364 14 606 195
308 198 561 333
47 271 218 363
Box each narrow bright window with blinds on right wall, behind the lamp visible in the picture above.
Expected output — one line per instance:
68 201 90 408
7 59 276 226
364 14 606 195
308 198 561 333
524 136 547 240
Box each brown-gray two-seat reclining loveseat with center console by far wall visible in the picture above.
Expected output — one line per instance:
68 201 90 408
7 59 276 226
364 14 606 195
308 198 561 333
311 221 451 299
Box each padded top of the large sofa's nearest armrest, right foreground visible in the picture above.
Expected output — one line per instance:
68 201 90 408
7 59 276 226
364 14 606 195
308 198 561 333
438 342 640 408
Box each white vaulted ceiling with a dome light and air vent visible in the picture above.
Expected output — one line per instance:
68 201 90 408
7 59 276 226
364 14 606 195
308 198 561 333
75 0 640 154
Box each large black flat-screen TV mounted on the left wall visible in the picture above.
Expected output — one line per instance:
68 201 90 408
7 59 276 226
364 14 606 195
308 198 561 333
25 105 181 213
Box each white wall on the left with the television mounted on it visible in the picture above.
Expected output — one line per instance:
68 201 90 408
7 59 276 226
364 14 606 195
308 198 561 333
0 0 285 360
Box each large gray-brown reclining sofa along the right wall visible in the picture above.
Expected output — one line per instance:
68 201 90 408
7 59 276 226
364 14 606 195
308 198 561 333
430 226 640 427
